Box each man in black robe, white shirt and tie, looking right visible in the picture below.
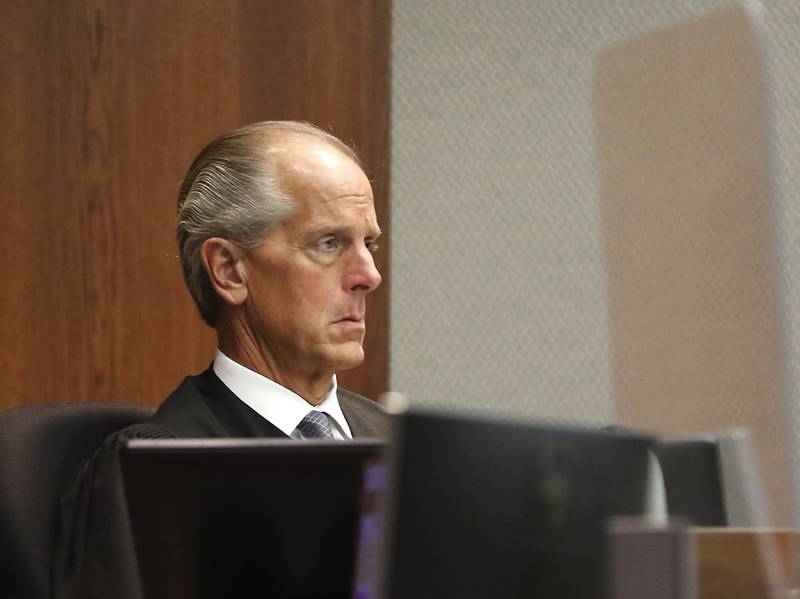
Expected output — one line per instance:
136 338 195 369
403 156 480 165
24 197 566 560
54 122 388 597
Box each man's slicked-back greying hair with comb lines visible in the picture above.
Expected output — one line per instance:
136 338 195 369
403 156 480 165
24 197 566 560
176 121 361 327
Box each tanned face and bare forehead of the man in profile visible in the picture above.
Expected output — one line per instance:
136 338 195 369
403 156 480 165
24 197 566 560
244 138 381 377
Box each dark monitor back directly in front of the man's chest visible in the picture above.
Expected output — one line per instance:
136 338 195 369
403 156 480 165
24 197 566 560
122 439 383 599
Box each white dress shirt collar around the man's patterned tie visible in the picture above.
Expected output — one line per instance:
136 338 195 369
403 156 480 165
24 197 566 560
214 350 353 439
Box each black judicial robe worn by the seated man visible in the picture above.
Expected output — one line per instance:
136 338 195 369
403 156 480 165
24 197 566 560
53 368 389 599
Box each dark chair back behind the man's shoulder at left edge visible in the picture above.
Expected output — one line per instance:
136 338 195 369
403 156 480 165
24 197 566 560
0 403 153 599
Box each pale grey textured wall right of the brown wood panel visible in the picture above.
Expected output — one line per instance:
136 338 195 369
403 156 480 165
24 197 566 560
391 0 800 438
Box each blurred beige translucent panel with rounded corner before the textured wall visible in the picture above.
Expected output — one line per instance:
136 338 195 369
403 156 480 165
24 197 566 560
594 6 794 528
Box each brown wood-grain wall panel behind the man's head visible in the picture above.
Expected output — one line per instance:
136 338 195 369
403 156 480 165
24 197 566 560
0 0 390 408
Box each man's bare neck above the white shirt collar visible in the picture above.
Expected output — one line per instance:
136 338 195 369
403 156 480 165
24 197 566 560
217 322 333 406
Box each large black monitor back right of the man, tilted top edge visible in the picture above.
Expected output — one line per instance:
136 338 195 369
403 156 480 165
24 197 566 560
376 413 651 599
